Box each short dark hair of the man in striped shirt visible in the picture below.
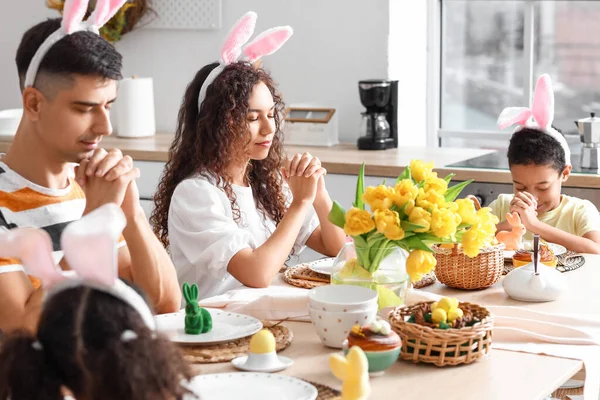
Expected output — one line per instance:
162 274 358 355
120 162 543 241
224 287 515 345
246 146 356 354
15 18 122 90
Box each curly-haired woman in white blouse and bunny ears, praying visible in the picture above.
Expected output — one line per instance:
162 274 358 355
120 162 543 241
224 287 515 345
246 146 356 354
151 12 345 298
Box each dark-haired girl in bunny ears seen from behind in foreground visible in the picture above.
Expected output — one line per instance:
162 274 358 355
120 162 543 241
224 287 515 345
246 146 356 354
0 204 191 400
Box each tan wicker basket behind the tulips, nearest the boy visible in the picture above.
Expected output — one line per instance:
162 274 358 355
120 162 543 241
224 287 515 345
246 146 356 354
432 243 505 290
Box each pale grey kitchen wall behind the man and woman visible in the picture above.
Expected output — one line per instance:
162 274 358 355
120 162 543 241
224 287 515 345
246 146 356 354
0 0 395 141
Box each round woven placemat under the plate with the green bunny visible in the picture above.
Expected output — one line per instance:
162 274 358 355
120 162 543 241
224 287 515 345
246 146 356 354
179 321 294 364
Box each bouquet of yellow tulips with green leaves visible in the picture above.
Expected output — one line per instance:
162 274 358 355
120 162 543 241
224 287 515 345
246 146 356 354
329 160 498 282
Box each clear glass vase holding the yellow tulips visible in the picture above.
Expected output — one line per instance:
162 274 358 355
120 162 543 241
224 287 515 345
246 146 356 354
331 243 411 309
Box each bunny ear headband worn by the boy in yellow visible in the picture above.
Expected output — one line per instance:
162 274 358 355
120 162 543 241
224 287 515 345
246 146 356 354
498 74 571 165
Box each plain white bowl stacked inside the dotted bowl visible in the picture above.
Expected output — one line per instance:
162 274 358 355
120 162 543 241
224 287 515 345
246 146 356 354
308 285 377 312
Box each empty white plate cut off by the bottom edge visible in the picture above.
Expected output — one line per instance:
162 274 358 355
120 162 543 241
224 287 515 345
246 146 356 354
187 372 318 400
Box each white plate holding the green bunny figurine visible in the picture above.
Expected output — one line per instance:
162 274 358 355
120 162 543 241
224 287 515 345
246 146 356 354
154 308 262 345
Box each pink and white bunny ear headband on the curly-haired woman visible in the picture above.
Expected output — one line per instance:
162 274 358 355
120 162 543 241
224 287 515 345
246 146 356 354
198 11 293 111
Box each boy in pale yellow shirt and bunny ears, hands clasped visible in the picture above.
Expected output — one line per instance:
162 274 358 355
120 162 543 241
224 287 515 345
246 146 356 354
490 74 600 254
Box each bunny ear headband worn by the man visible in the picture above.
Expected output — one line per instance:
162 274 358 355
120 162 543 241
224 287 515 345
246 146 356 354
25 0 127 87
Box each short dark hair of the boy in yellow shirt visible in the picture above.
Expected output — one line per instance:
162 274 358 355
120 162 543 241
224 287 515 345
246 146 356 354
507 127 566 173
